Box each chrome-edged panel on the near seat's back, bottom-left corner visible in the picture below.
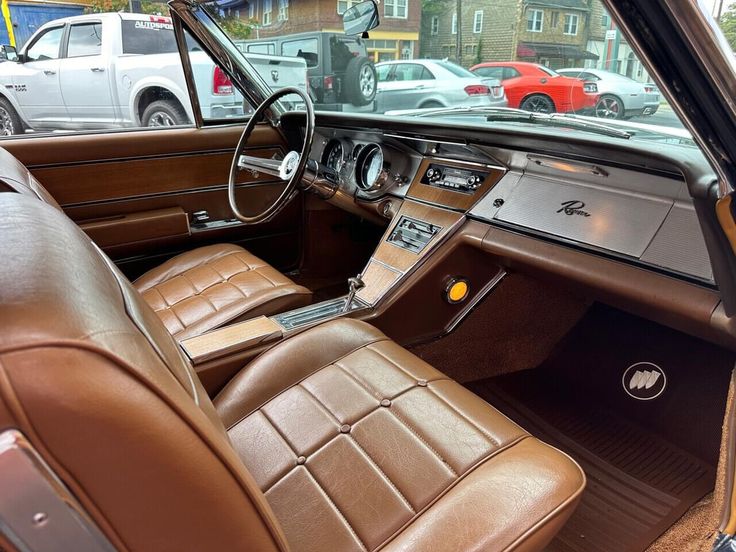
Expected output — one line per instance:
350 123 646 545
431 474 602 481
0 429 115 552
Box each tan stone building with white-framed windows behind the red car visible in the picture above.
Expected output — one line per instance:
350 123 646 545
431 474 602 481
420 0 598 68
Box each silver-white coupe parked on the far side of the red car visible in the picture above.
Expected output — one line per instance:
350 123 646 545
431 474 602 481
557 68 659 119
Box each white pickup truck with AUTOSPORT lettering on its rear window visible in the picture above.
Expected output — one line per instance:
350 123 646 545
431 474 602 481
0 13 307 135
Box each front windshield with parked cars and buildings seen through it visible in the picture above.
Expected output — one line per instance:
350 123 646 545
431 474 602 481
194 0 736 146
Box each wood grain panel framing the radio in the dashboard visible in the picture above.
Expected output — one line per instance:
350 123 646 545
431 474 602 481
406 161 506 211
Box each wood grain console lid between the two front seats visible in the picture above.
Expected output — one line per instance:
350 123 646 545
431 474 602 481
181 316 283 365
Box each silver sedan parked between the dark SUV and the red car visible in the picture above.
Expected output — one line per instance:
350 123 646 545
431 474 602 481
376 59 507 113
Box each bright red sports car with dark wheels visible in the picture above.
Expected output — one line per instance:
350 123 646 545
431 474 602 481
470 61 598 113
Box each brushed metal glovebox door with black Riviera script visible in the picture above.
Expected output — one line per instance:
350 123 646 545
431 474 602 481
494 175 673 258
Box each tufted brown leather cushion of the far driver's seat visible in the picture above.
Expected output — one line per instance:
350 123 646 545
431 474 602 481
133 244 312 340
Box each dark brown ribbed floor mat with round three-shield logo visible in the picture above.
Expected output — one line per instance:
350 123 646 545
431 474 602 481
467 309 733 552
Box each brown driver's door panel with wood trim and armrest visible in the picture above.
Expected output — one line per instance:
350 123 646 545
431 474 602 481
2 125 302 278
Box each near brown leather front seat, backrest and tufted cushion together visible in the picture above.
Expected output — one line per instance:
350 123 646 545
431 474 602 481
0 194 585 551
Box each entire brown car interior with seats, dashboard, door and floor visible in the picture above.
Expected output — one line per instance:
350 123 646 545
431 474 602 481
0 0 736 552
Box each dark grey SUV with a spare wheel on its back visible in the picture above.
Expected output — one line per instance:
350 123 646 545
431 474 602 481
235 31 378 111
